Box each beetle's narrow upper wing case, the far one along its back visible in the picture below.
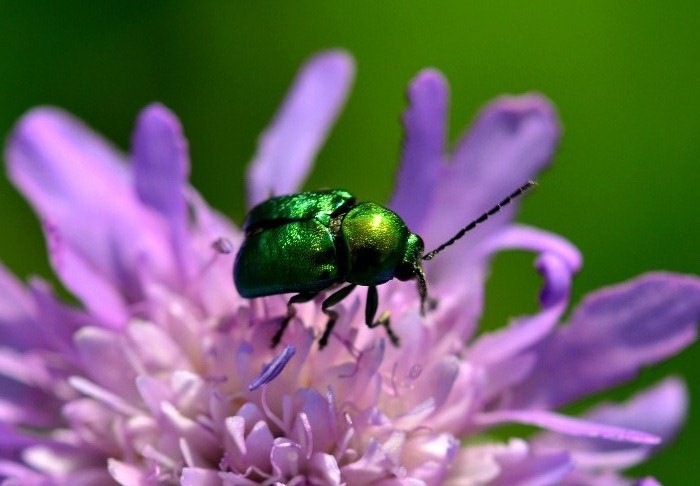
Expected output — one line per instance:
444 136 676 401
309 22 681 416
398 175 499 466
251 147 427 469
243 189 355 233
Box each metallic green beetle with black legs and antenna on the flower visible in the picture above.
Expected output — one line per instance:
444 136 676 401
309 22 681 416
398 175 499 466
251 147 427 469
233 181 534 348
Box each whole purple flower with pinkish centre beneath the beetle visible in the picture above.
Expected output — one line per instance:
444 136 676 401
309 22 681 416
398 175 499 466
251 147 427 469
0 52 700 485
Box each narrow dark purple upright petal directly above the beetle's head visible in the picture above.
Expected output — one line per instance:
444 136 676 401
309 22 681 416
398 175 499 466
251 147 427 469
388 69 449 232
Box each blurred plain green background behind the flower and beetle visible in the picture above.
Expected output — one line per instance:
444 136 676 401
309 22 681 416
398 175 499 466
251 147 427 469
0 1 700 484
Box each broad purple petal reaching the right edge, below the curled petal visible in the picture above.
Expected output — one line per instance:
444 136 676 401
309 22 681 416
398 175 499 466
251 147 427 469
513 273 700 408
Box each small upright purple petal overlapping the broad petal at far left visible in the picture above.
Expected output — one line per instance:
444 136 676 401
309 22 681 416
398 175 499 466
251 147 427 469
132 104 190 276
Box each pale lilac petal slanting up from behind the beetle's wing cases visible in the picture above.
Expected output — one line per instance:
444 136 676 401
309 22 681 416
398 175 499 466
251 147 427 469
247 51 355 207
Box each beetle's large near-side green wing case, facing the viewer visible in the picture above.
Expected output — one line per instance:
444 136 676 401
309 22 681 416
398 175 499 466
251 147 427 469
233 219 342 298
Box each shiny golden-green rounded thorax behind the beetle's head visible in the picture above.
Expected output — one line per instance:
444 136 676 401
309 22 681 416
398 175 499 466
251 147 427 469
339 203 410 285
